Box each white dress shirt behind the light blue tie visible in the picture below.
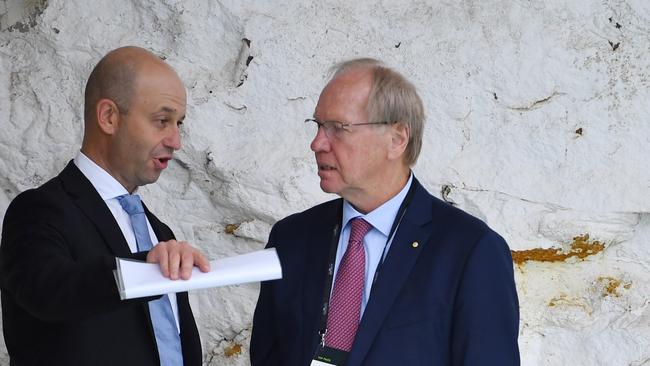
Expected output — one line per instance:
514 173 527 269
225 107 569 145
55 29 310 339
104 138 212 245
74 151 180 333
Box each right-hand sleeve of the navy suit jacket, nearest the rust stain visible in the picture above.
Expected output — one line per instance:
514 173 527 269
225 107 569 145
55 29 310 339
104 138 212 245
452 230 519 366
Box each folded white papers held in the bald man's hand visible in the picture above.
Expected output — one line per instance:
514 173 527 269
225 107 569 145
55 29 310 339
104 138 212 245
114 248 282 300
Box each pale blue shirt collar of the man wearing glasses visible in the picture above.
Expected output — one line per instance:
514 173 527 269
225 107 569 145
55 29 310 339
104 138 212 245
343 173 413 237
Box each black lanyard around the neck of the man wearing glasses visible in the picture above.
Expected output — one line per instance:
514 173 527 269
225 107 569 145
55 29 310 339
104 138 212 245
318 182 415 347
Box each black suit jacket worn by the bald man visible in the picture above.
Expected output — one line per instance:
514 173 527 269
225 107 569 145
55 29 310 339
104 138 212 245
0 162 202 366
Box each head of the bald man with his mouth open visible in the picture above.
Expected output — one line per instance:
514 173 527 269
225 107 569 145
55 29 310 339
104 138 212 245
81 47 187 192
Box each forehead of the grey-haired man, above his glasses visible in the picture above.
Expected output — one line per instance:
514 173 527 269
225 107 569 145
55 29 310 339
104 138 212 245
314 70 372 120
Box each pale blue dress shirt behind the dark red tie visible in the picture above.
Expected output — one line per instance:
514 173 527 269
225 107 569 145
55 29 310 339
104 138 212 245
332 174 413 314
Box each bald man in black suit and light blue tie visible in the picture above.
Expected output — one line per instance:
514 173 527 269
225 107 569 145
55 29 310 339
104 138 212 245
0 47 209 366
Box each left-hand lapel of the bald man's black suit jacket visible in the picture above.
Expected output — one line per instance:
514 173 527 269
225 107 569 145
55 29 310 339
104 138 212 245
59 161 131 257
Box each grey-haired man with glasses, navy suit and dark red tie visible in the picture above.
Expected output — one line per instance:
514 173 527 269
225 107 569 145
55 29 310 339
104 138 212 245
250 59 519 366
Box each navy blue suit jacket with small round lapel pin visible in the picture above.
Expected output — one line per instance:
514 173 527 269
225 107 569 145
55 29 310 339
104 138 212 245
250 179 519 366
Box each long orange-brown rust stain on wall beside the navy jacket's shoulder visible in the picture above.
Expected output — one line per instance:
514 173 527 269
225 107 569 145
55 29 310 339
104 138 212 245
511 234 605 265
